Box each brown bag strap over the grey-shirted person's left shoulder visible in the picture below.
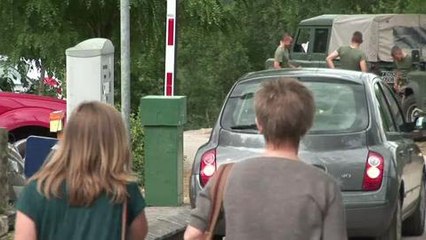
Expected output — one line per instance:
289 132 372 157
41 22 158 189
205 163 234 239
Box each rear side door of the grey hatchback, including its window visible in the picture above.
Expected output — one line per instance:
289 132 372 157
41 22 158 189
379 82 423 208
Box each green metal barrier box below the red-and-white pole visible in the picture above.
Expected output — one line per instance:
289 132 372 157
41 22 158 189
140 96 186 206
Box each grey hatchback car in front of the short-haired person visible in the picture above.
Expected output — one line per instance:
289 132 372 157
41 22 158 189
190 68 426 240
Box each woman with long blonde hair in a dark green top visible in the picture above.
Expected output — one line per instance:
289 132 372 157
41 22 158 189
15 102 147 240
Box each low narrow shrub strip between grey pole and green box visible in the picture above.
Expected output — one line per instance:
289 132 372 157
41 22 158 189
130 114 145 186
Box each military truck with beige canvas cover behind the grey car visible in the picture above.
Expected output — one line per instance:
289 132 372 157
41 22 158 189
266 14 426 122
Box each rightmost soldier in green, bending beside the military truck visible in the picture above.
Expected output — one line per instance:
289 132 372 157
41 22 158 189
391 46 413 92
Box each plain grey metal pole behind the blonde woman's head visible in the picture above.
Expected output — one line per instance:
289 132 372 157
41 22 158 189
120 0 130 137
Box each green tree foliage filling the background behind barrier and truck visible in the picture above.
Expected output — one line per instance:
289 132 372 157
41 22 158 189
0 0 426 128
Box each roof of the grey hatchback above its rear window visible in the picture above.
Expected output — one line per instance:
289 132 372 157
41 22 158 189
238 68 377 85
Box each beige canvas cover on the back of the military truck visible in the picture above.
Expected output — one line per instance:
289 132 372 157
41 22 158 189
329 14 426 62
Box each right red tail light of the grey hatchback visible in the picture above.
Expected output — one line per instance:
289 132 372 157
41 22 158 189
362 152 385 191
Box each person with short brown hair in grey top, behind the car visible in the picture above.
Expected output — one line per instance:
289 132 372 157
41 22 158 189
184 78 347 240
